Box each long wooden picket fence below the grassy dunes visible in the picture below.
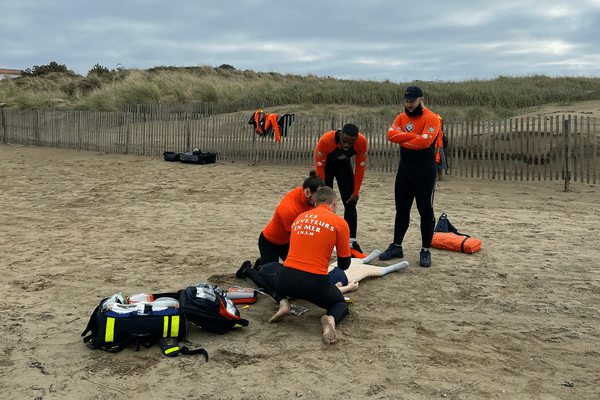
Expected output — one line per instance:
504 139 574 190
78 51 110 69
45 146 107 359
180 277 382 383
0 109 600 189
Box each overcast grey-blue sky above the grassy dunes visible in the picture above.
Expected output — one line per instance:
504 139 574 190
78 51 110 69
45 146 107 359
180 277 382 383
0 0 600 82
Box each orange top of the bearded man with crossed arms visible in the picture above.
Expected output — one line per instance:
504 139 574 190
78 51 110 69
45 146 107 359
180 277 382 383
387 107 442 150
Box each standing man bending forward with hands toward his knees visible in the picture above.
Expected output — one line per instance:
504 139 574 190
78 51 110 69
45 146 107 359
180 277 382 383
315 124 367 255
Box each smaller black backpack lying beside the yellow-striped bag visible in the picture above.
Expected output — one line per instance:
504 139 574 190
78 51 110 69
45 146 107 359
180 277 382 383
179 282 248 335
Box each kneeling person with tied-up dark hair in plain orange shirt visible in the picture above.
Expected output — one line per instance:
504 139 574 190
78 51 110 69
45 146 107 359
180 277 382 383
236 170 325 278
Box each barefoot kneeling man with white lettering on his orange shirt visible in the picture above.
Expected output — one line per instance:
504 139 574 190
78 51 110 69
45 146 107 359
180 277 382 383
248 187 351 344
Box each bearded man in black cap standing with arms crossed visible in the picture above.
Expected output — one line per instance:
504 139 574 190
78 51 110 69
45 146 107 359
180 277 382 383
379 86 442 267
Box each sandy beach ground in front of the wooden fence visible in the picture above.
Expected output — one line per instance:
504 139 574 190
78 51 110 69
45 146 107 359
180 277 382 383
0 140 600 400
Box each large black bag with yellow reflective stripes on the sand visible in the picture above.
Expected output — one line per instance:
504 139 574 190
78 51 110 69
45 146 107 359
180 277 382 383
81 292 208 361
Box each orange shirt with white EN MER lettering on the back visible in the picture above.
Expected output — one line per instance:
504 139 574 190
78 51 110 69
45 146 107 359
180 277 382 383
283 204 351 275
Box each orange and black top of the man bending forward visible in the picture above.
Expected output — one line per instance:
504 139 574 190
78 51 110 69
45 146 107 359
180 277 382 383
315 131 368 195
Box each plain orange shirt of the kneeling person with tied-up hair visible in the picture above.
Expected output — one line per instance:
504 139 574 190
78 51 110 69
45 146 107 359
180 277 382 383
263 186 313 244
